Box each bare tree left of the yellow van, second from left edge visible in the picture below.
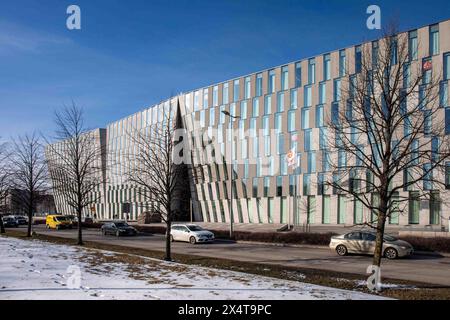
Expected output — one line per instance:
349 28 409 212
11 133 48 237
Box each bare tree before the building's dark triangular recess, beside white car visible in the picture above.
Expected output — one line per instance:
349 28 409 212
125 99 189 261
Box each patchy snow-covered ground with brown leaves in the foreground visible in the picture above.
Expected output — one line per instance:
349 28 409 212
0 237 382 300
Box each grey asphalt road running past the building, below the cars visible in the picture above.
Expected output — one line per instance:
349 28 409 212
9 226 450 286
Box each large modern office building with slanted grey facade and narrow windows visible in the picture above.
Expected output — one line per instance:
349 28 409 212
46 20 450 228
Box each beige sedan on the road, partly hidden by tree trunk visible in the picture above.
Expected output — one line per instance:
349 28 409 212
330 231 414 259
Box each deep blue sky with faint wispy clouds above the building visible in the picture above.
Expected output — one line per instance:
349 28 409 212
0 0 450 138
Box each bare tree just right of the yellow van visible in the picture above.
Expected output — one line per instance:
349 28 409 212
46 103 104 245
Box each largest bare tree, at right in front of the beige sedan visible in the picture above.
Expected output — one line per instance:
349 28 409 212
326 24 450 266
